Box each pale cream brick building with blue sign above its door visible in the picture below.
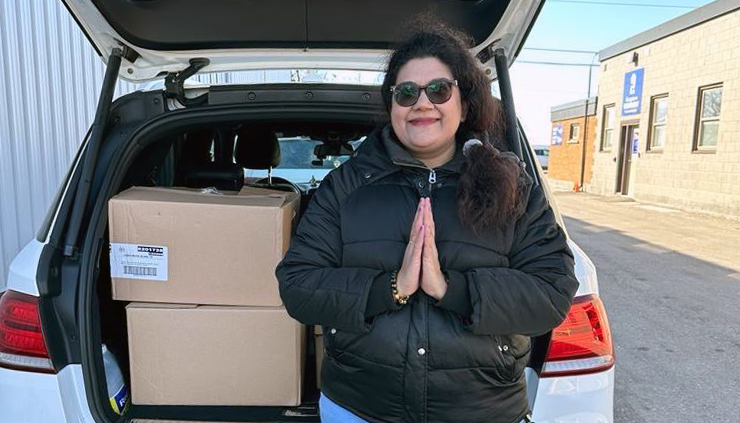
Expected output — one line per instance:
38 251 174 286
588 0 740 216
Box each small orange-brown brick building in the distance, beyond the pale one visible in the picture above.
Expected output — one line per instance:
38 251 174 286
547 98 597 190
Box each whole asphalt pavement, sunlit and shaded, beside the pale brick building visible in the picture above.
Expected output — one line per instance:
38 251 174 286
555 192 740 423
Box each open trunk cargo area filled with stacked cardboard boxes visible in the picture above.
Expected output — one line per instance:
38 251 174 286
96 131 322 422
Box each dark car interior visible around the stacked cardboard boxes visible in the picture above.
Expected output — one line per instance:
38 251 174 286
93 118 374 421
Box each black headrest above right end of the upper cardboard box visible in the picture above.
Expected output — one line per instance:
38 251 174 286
234 126 280 169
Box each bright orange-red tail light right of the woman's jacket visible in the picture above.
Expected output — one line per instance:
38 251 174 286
540 295 614 377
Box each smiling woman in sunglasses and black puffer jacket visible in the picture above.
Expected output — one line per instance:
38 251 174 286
277 22 578 423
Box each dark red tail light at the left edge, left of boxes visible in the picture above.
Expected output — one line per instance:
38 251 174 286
0 291 54 373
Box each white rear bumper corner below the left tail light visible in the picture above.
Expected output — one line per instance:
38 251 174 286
0 364 95 423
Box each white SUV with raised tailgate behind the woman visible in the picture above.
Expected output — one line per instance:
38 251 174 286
0 0 615 423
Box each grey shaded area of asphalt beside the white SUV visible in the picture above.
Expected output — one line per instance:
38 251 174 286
565 217 740 423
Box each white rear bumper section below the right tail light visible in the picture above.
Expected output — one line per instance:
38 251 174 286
532 367 614 423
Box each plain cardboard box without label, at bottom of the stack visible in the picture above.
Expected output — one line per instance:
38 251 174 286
126 303 305 406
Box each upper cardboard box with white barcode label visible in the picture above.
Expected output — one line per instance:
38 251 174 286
108 187 300 306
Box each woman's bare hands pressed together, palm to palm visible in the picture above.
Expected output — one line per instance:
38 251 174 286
396 198 447 301
